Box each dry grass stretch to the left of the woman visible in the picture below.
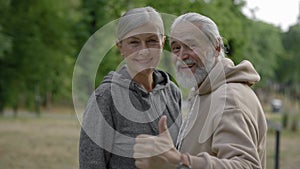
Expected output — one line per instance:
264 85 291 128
0 111 80 169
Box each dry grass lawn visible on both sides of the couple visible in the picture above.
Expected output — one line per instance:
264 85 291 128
0 109 300 169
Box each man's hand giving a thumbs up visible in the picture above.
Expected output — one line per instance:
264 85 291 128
133 116 180 169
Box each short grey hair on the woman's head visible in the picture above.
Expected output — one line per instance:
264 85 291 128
117 7 164 41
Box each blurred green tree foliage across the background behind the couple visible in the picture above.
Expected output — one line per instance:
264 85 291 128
0 0 300 111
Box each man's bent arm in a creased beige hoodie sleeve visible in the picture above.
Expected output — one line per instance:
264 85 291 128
190 109 262 169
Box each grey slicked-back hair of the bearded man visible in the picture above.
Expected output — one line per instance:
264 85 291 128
171 12 225 58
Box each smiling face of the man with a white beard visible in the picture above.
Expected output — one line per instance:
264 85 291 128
170 23 215 88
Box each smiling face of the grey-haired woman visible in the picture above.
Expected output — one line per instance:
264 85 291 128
117 24 164 75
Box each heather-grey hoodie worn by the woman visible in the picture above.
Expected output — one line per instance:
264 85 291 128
79 66 181 169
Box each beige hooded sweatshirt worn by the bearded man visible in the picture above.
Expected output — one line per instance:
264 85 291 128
179 58 267 169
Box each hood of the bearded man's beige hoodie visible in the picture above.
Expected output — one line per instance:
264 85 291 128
195 58 260 95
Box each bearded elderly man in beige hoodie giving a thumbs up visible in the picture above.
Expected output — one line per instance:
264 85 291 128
134 13 267 169
